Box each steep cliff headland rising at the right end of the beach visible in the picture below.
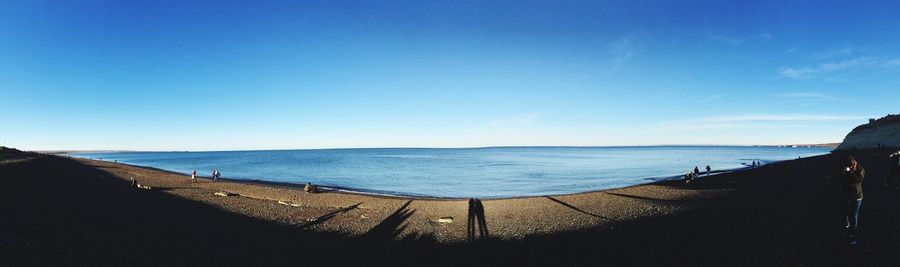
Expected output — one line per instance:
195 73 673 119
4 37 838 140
837 114 900 150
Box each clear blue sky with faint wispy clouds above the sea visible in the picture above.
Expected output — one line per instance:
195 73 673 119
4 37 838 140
0 0 900 150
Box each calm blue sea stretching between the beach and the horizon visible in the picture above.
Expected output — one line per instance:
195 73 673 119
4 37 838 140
73 146 830 198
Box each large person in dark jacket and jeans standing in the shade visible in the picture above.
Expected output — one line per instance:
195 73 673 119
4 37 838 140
838 156 866 244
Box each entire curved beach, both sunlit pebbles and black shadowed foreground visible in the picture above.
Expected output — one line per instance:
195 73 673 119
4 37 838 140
0 150 900 266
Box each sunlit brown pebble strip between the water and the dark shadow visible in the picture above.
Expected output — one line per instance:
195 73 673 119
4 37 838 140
59 158 744 244
